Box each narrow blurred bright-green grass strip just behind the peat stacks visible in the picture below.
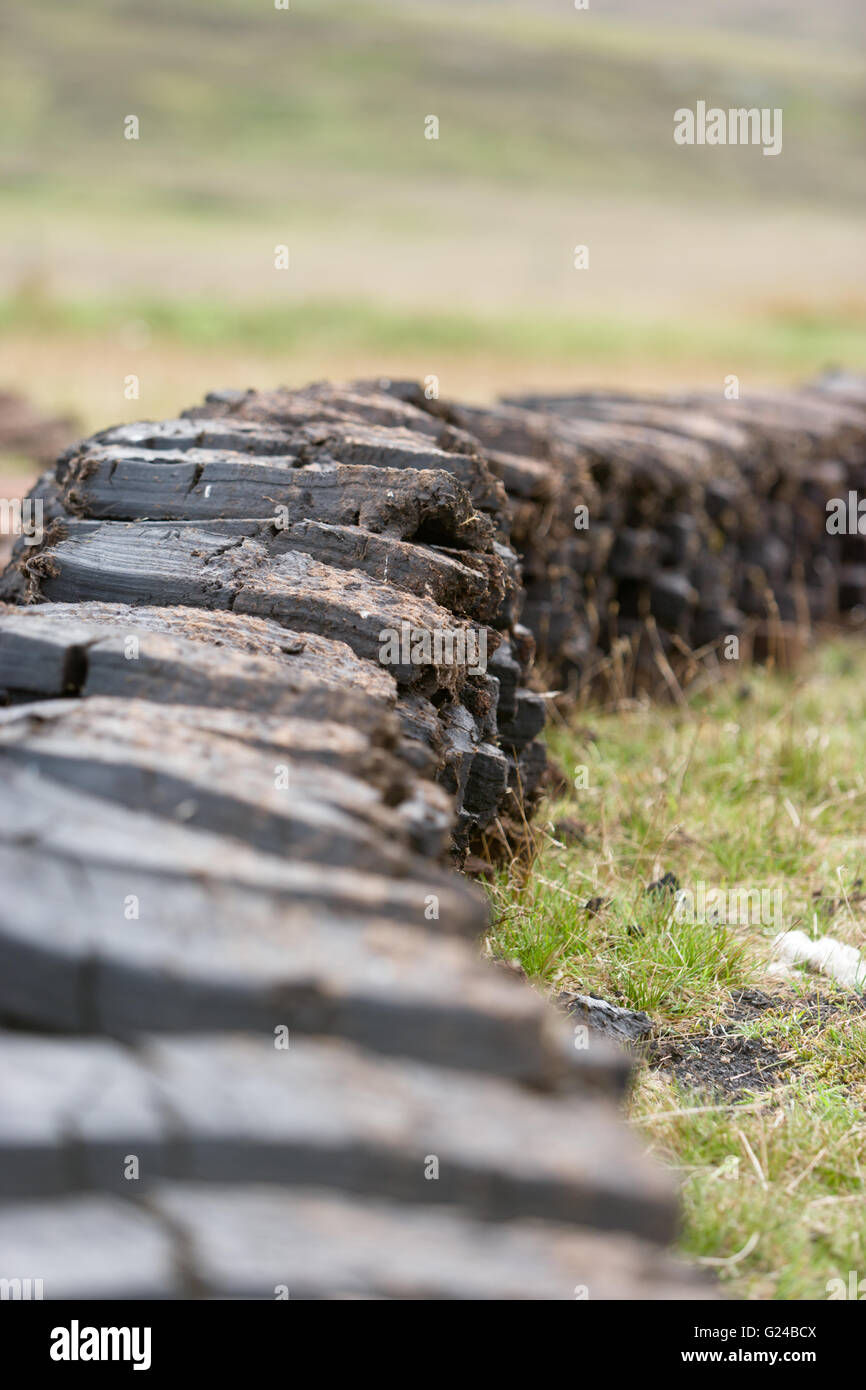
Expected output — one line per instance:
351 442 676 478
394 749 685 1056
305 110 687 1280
0 292 866 374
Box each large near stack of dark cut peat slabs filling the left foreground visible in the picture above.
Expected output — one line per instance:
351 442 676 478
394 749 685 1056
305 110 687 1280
0 391 706 1300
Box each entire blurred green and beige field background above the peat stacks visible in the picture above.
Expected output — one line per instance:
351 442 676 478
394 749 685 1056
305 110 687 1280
0 0 866 431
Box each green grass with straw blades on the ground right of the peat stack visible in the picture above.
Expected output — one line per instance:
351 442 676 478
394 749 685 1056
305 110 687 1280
491 642 866 1298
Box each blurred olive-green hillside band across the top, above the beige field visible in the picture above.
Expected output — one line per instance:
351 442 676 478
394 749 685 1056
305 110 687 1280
0 0 865 203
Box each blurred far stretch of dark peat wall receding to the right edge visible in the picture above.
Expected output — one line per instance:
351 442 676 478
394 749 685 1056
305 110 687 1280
370 377 866 688
